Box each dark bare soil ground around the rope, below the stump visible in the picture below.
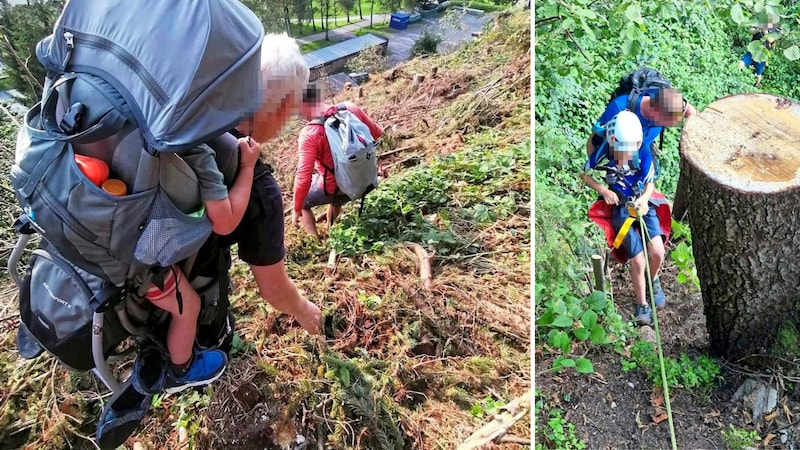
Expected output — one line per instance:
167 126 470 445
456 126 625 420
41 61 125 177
535 265 800 450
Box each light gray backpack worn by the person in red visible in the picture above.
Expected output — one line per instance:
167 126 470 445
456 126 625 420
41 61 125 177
311 103 378 201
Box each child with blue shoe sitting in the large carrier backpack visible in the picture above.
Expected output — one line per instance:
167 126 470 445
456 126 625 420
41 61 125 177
146 138 259 393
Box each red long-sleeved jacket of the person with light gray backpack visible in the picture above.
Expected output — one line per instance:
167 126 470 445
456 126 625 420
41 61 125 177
294 102 383 212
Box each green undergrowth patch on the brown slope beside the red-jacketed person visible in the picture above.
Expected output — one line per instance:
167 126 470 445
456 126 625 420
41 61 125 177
330 131 530 257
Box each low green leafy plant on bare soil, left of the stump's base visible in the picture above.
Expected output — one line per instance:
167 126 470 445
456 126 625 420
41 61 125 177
623 341 720 393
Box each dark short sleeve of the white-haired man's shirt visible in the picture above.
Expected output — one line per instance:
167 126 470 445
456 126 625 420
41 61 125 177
222 161 286 266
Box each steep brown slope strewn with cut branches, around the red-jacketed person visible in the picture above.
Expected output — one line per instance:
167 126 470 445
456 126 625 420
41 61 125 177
0 7 531 450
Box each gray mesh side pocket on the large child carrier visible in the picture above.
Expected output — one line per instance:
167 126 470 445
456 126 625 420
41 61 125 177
134 190 211 267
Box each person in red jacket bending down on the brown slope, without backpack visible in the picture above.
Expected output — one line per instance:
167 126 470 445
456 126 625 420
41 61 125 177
292 84 383 239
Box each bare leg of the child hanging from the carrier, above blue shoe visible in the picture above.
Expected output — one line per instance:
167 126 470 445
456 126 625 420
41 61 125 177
147 267 200 368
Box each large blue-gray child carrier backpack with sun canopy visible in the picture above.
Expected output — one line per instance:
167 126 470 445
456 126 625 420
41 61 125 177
11 0 264 370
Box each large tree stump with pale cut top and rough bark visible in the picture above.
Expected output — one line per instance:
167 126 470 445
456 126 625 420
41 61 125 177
681 94 800 359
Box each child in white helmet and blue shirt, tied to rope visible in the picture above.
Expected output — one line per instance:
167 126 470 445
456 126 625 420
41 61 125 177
582 110 666 325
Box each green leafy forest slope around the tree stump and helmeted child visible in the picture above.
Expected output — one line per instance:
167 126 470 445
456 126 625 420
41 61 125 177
534 0 800 449
